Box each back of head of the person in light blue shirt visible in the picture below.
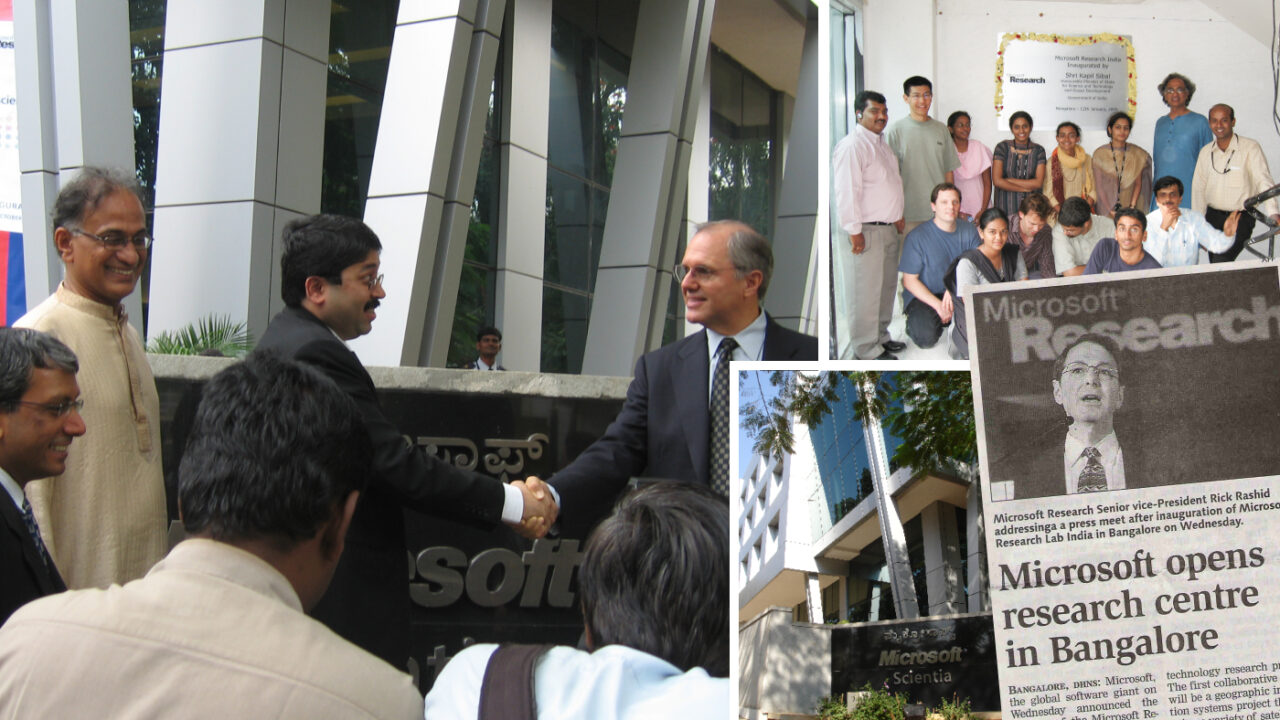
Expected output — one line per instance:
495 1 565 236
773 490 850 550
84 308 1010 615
579 483 730 678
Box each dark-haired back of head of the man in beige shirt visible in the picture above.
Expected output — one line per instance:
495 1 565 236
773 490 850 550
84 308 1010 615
178 352 372 607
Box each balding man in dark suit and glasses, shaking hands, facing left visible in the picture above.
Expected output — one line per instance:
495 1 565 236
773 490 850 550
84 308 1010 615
548 215 818 524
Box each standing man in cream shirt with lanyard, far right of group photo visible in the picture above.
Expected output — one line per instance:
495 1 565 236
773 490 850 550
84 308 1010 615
1192 102 1280 263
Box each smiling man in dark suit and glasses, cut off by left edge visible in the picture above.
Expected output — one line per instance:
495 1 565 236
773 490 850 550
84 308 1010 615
0 328 84 623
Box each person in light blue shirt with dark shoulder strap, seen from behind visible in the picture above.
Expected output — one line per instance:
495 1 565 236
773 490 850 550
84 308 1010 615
425 483 732 720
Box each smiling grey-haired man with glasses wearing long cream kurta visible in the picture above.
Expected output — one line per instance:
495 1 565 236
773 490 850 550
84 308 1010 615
15 168 168 588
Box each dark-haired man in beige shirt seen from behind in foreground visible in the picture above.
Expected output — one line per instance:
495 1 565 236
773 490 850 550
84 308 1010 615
0 354 424 720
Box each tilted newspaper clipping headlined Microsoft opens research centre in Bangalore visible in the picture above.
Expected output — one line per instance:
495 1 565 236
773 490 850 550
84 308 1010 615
966 264 1280 720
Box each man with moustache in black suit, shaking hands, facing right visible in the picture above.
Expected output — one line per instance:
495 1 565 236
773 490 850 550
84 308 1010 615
257 215 556 670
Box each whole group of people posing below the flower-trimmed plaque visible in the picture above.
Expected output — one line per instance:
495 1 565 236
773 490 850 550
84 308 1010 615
831 73 1280 360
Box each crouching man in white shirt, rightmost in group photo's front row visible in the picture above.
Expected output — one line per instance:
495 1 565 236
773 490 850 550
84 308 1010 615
1142 176 1240 268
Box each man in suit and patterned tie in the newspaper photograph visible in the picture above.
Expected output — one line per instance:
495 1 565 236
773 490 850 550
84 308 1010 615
992 333 1136 500
